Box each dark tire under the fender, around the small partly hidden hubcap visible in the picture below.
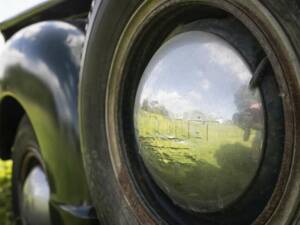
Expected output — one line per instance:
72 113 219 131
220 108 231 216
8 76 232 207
12 116 50 225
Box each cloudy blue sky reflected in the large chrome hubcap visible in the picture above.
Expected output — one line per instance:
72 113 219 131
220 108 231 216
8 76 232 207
138 31 252 120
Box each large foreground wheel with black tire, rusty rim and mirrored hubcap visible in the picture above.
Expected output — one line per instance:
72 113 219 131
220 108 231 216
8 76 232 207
79 0 300 225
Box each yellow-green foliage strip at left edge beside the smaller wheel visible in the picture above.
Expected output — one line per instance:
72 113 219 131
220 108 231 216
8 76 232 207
0 160 12 225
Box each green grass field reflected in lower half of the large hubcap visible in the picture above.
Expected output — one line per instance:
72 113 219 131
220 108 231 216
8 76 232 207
137 111 261 209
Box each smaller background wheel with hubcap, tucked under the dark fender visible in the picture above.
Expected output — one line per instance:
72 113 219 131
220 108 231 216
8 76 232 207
12 117 51 225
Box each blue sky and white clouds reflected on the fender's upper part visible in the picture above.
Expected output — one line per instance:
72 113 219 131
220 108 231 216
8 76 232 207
0 21 84 126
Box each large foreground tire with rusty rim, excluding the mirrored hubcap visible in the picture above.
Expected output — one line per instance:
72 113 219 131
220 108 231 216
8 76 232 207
79 0 300 225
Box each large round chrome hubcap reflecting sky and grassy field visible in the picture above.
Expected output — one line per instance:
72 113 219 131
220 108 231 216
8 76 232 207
135 31 264 212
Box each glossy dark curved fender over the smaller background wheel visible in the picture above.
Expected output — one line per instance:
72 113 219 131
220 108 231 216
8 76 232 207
0 21 96 223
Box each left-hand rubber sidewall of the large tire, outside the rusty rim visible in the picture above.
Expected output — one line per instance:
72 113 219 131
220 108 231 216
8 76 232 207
79 0 141 225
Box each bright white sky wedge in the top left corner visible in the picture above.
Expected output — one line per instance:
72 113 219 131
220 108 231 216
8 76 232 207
0 0 47 22
